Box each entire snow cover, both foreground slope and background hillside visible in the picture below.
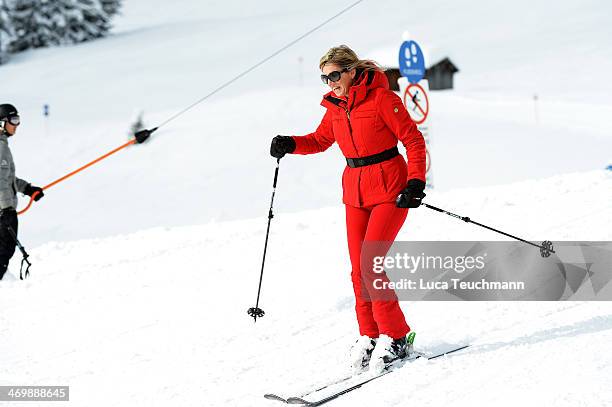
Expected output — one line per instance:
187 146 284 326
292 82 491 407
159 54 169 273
0 0 612 407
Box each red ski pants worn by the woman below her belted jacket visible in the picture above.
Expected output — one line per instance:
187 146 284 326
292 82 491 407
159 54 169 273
345 203 410 339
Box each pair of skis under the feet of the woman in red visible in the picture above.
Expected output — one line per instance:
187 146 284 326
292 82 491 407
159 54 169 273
264 345 470 406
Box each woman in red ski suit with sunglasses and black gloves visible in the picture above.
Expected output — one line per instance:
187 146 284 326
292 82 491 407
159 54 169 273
270 45 426 370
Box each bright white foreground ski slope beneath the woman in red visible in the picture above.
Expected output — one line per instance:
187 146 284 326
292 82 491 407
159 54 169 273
0 171 612 407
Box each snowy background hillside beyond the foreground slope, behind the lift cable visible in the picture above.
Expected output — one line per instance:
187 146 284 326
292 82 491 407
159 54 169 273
0 0 612 246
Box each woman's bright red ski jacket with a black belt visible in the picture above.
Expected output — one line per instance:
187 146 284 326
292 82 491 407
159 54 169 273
293 71 426 207
